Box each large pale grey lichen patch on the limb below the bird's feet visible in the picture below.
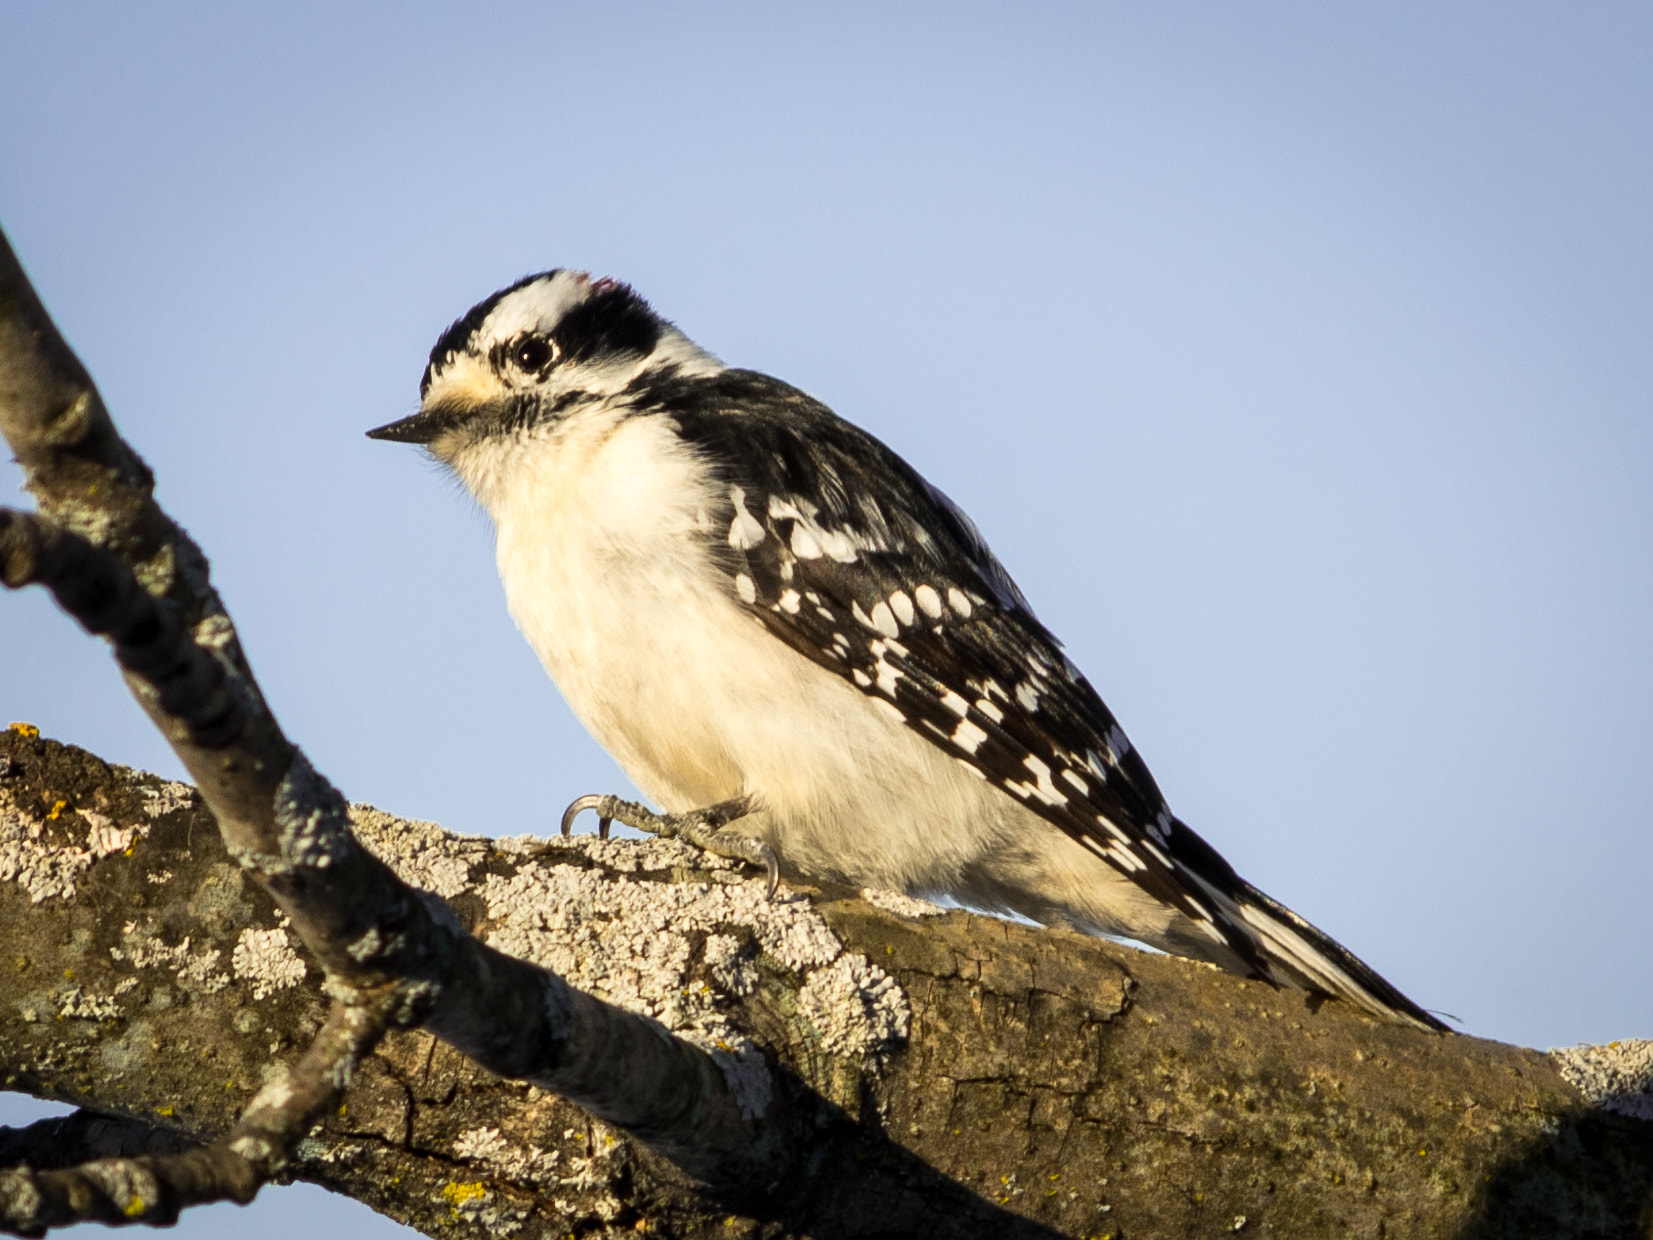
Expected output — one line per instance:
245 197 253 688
350 805 929 1118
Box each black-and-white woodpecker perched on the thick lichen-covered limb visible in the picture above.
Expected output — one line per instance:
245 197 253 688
367 268 1445 1030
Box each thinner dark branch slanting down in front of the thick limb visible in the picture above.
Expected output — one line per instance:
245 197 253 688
0 223 775 1230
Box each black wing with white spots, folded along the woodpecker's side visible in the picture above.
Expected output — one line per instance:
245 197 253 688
648 370 1440 1028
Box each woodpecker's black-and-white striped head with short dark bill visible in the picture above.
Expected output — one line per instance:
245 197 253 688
367 268 722 468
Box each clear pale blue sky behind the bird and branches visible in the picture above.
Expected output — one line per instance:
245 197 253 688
0 0 1653 1237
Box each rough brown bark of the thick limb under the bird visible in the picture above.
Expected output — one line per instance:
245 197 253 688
0 731 1653 1240
